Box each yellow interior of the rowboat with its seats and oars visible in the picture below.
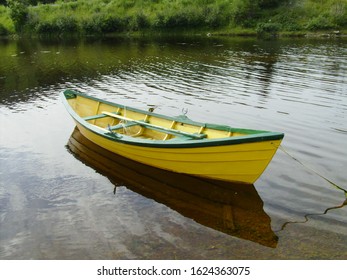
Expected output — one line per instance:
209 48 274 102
68 95 247 141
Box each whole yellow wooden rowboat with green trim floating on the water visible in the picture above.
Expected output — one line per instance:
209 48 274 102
62 90 284 184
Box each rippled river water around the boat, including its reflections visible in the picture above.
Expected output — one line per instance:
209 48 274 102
0 37 347 259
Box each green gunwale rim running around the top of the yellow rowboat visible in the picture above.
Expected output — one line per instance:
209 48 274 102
61 90 284 148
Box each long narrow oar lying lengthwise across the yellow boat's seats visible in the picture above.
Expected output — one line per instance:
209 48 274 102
102 111 207 139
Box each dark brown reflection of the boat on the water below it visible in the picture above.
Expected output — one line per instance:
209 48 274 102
67 128 278 248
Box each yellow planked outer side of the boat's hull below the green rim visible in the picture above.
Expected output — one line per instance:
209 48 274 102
77 122 281 184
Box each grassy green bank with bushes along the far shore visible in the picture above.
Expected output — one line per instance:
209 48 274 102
0 0 347 35
